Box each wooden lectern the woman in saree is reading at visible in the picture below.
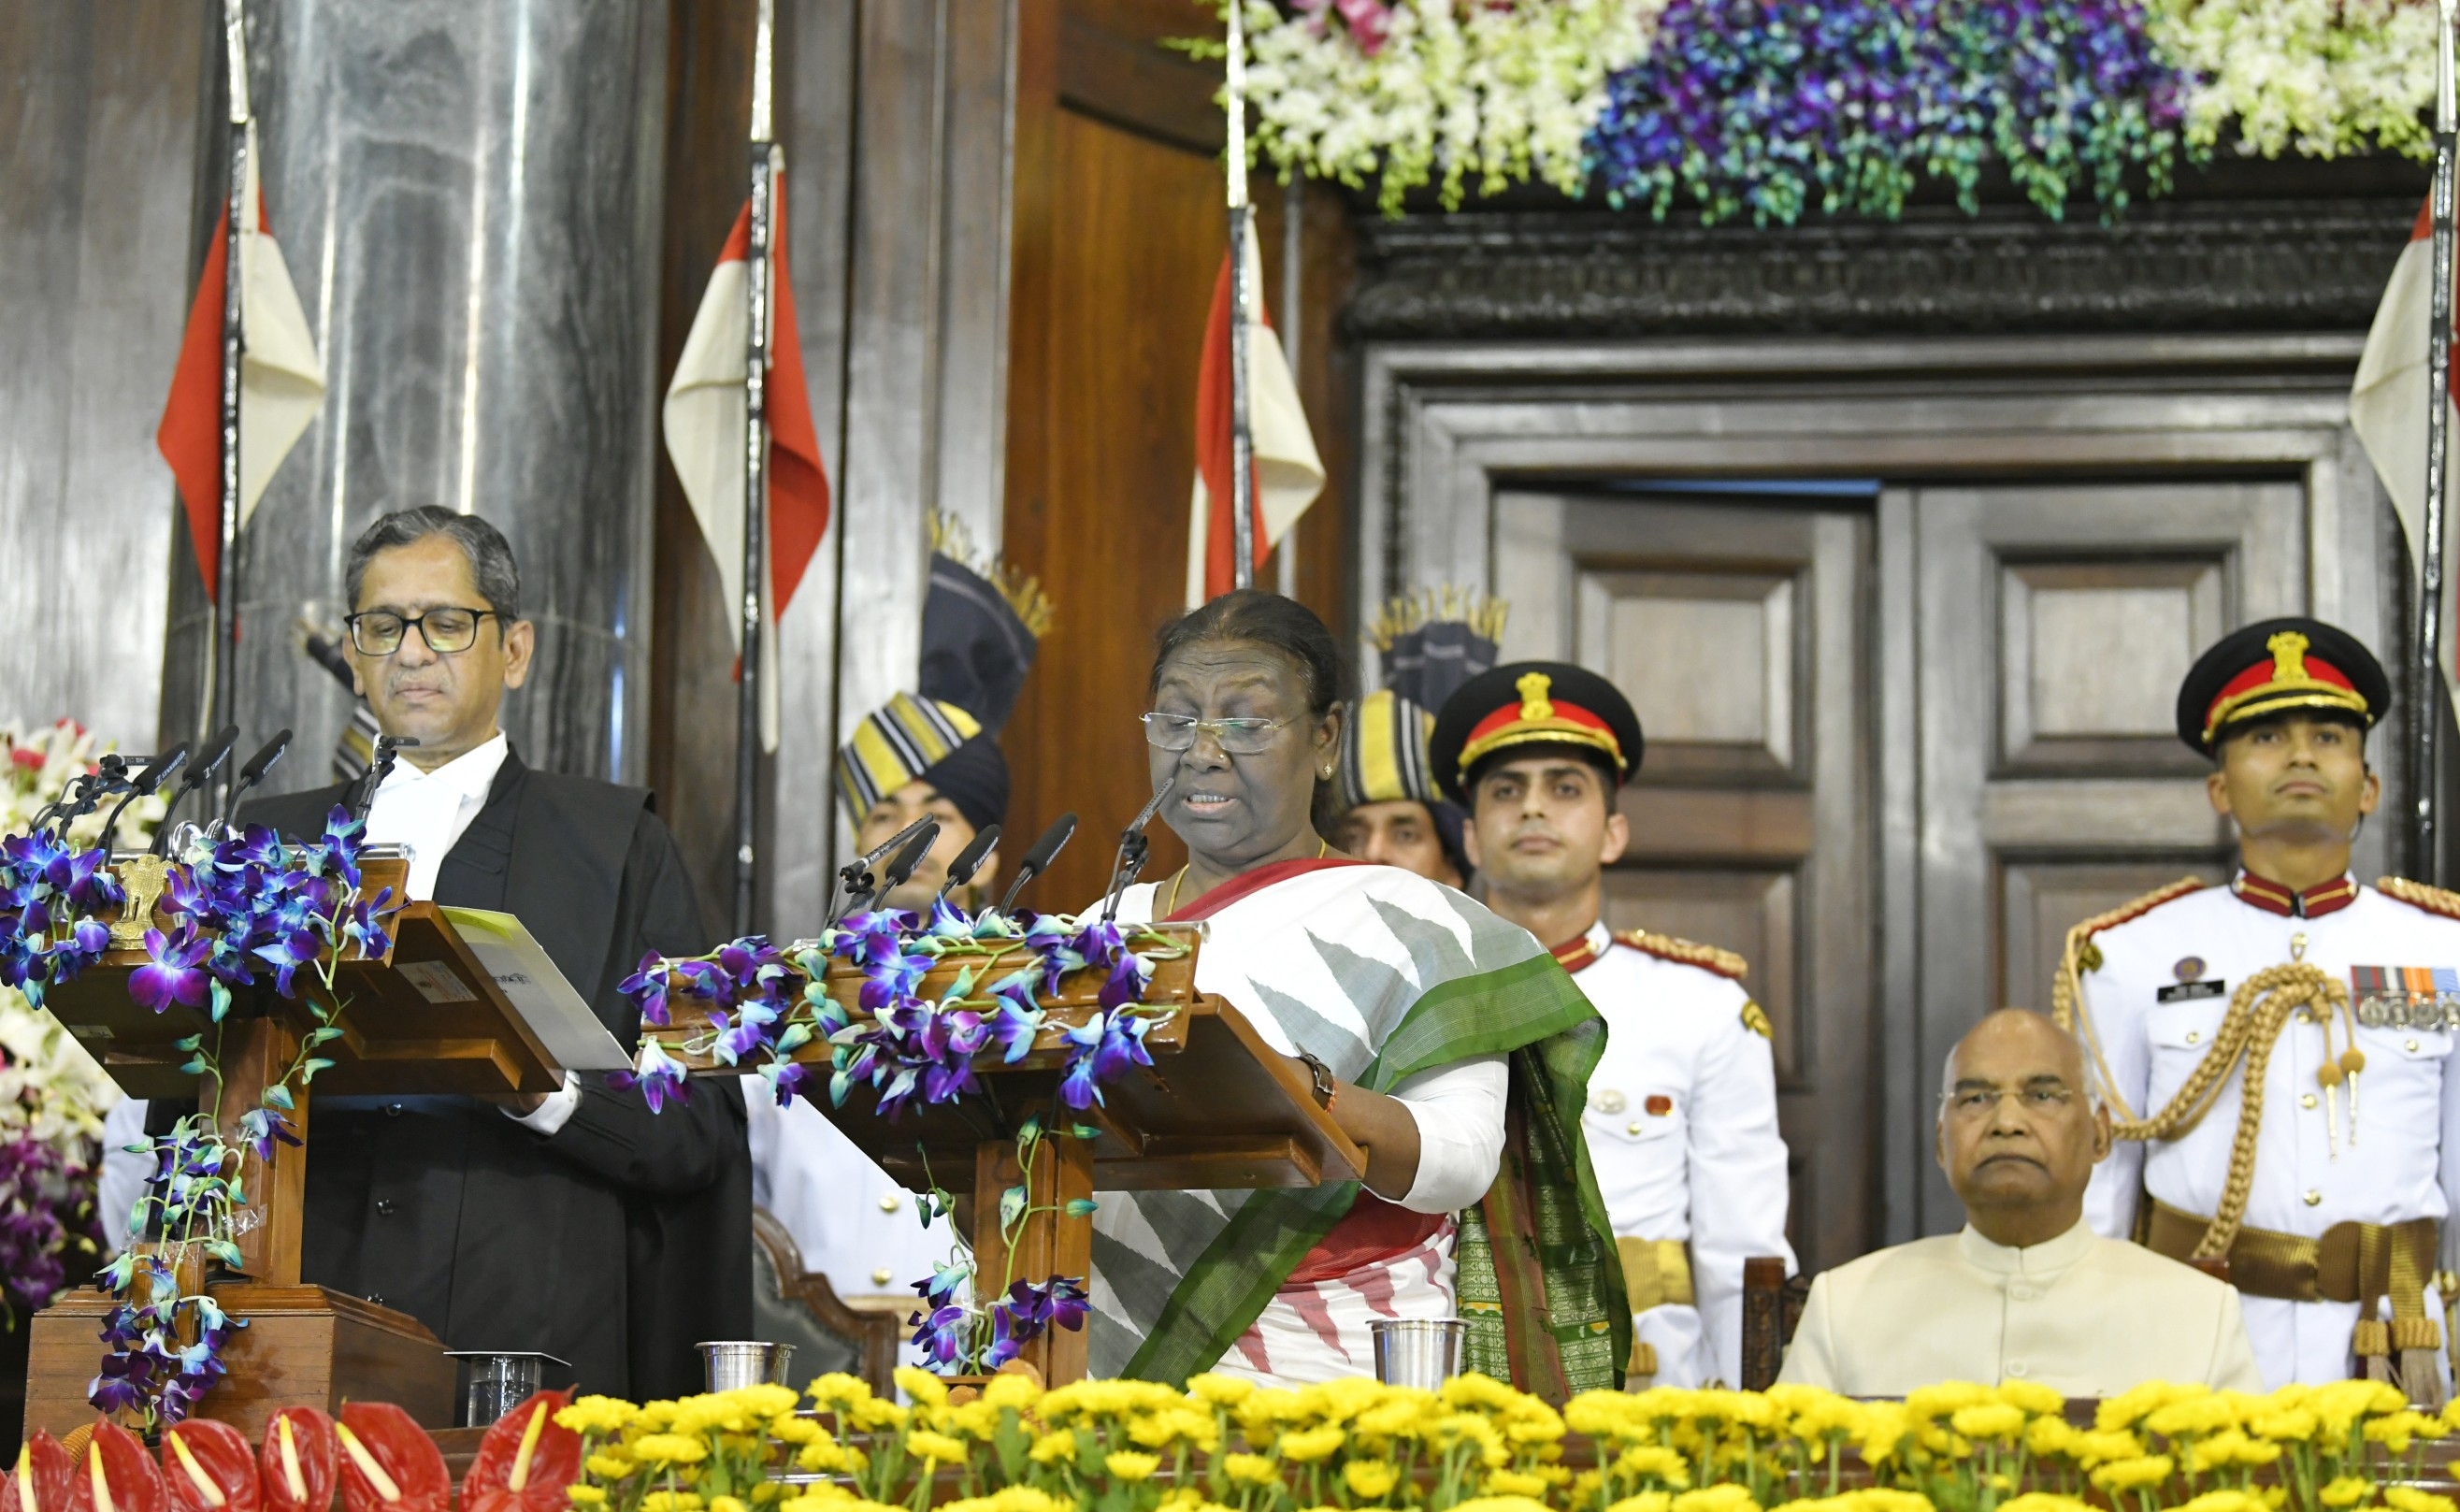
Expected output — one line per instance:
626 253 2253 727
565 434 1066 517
652 925 1368 1387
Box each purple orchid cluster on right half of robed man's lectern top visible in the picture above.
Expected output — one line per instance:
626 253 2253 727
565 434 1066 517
128 806 394 1023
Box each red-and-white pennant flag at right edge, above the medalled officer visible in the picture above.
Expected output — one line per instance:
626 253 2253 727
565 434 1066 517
2350 202 2460 696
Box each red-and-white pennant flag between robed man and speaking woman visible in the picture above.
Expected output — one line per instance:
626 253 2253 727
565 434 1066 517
667 180 829 750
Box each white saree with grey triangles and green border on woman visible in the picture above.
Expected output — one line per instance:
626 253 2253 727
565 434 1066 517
1087 866 1631 1394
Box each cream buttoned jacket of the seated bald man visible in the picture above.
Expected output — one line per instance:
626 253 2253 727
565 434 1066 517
1777 1222 2261 1396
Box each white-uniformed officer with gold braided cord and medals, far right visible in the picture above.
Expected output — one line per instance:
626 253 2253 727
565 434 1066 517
2054 620 2460 1402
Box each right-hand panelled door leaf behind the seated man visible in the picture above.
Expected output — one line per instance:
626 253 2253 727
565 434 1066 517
1882 482 2308 1231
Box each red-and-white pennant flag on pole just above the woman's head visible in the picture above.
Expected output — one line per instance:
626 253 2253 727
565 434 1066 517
1188 219 1323 610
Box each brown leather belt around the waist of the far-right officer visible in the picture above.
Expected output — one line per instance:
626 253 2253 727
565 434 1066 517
2143 1200 2443 1379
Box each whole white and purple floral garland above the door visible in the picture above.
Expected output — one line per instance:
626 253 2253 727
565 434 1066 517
1230 0 2436 223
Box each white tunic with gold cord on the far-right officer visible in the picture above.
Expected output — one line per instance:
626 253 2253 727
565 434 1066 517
2077 872 2460 1387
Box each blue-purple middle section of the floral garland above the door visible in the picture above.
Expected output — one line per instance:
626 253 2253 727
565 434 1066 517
1590 0 2190 223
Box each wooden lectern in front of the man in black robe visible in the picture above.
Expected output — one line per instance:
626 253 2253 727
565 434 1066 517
24 848 583 1441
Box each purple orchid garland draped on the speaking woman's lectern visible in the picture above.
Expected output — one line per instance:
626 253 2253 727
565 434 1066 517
617 898 1186 1375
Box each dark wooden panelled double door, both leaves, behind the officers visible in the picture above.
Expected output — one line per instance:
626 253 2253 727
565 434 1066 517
1490 480 2352 1269
